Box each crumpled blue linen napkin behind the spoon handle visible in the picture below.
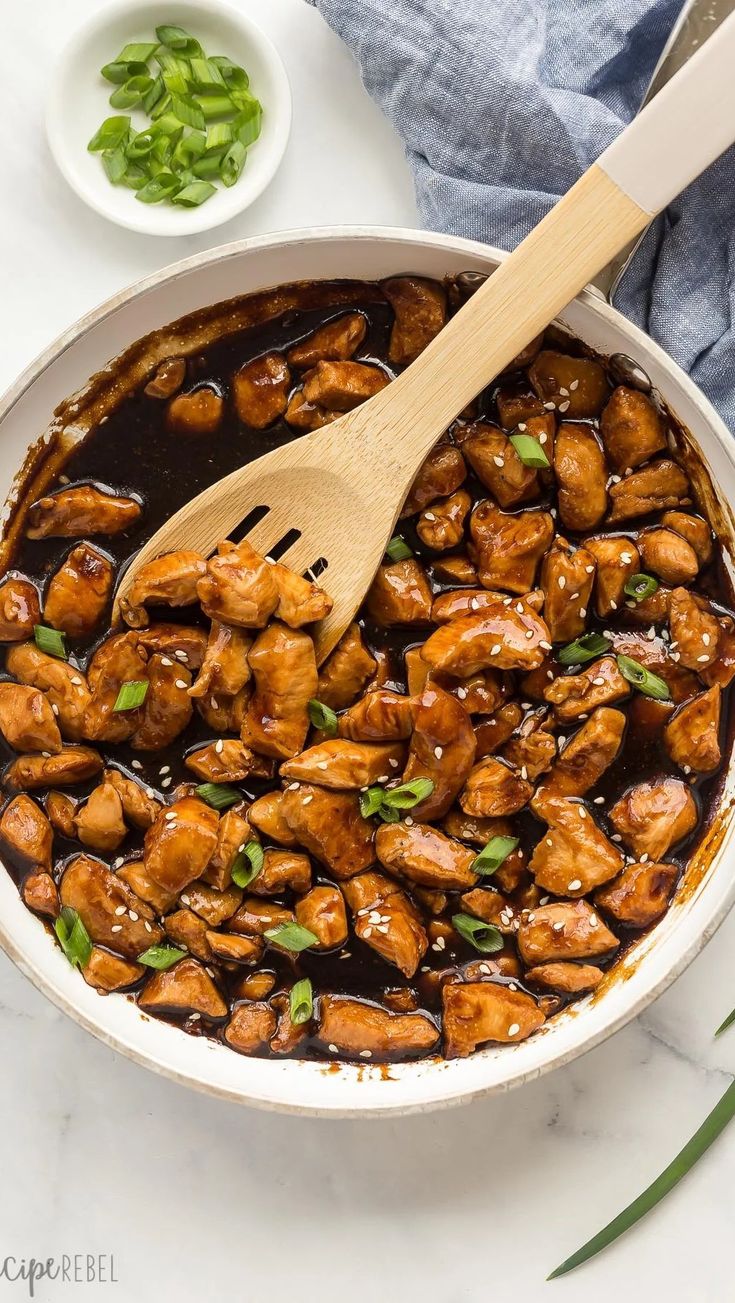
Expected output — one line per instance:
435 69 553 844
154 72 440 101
308 0 735 431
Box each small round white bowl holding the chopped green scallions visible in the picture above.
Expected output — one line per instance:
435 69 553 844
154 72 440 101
46 0 291 236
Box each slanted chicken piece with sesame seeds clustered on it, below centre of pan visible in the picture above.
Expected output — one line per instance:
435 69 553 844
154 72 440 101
343 873 429 977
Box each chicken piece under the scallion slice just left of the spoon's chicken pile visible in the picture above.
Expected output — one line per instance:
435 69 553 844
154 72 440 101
82 633 150 743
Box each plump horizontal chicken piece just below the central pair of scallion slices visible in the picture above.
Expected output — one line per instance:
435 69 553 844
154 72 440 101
375 823 477 891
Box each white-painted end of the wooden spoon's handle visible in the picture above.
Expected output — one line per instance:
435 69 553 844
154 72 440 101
597 7 735 216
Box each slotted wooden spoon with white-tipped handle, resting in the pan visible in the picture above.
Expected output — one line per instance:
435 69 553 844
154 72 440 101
115 16 735 661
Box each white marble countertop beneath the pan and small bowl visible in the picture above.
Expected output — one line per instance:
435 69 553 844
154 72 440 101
0 0 735 1303
